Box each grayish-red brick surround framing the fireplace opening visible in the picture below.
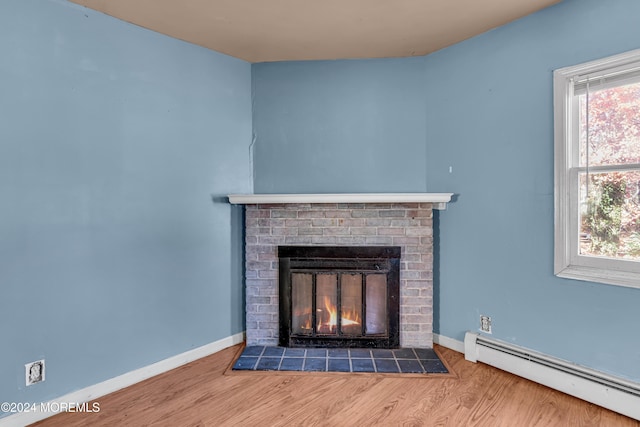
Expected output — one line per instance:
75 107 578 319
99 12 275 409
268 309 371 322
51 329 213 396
245 203 433 348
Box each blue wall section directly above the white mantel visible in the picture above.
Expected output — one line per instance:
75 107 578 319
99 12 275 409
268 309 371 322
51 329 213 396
252 58 426 193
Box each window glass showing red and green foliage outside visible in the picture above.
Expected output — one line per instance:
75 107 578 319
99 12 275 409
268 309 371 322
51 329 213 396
579 83 640 260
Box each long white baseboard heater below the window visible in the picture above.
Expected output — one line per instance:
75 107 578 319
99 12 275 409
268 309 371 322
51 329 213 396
464 332 640 420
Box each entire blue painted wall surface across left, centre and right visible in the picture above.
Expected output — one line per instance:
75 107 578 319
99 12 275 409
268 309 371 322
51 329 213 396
0 0 640 414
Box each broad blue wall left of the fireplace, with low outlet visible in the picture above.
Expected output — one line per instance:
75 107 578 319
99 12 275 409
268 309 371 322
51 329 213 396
0 0 251 410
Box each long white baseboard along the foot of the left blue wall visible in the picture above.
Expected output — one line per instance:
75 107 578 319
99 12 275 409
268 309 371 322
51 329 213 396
0 332 244 427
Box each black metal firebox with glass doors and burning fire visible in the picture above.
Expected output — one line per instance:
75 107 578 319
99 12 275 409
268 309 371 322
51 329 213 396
278 246 401 348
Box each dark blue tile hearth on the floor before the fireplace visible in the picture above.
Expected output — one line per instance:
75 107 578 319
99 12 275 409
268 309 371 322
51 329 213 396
233 346 449 374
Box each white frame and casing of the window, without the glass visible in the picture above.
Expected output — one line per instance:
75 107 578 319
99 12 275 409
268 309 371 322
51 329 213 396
553 49 640 288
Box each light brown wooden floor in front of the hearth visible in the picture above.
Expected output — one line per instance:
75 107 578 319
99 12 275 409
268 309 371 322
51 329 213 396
35 346 640 427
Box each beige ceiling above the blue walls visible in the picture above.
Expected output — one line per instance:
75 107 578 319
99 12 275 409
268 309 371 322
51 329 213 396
70 0 560 62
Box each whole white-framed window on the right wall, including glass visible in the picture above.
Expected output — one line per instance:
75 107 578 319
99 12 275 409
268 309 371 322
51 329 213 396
554 50 640 288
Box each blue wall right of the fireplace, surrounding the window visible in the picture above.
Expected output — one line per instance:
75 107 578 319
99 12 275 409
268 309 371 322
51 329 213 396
425 0 640 381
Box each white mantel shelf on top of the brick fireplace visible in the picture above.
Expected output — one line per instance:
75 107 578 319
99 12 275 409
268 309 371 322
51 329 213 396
228 193 453 210
